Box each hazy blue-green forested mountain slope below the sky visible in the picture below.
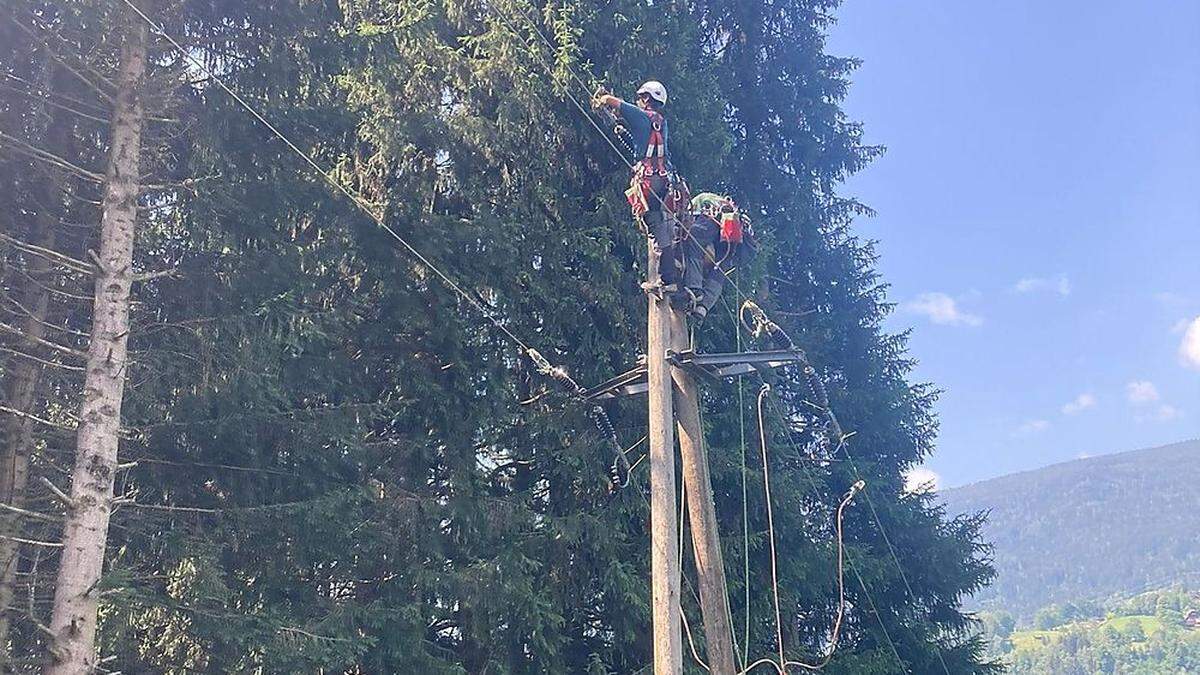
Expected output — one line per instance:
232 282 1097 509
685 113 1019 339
942 441 1200 617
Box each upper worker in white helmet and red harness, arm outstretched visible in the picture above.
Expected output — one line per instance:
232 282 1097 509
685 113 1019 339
592 79 679 293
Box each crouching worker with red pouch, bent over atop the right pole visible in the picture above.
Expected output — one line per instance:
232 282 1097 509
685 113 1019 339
673 192 754 321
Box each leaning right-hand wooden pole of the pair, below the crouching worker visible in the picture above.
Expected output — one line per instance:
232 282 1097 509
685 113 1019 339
671 310 737 675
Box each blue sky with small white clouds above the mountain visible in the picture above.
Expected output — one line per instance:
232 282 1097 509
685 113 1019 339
829 0 1200 486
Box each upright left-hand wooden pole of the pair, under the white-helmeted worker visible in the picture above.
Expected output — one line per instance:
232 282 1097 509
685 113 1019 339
646 239 683 675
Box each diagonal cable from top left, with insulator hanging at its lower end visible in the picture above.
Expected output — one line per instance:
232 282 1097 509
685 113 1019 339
121 0 630 488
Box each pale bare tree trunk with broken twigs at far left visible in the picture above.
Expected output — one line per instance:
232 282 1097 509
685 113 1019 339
47 12 146 675
